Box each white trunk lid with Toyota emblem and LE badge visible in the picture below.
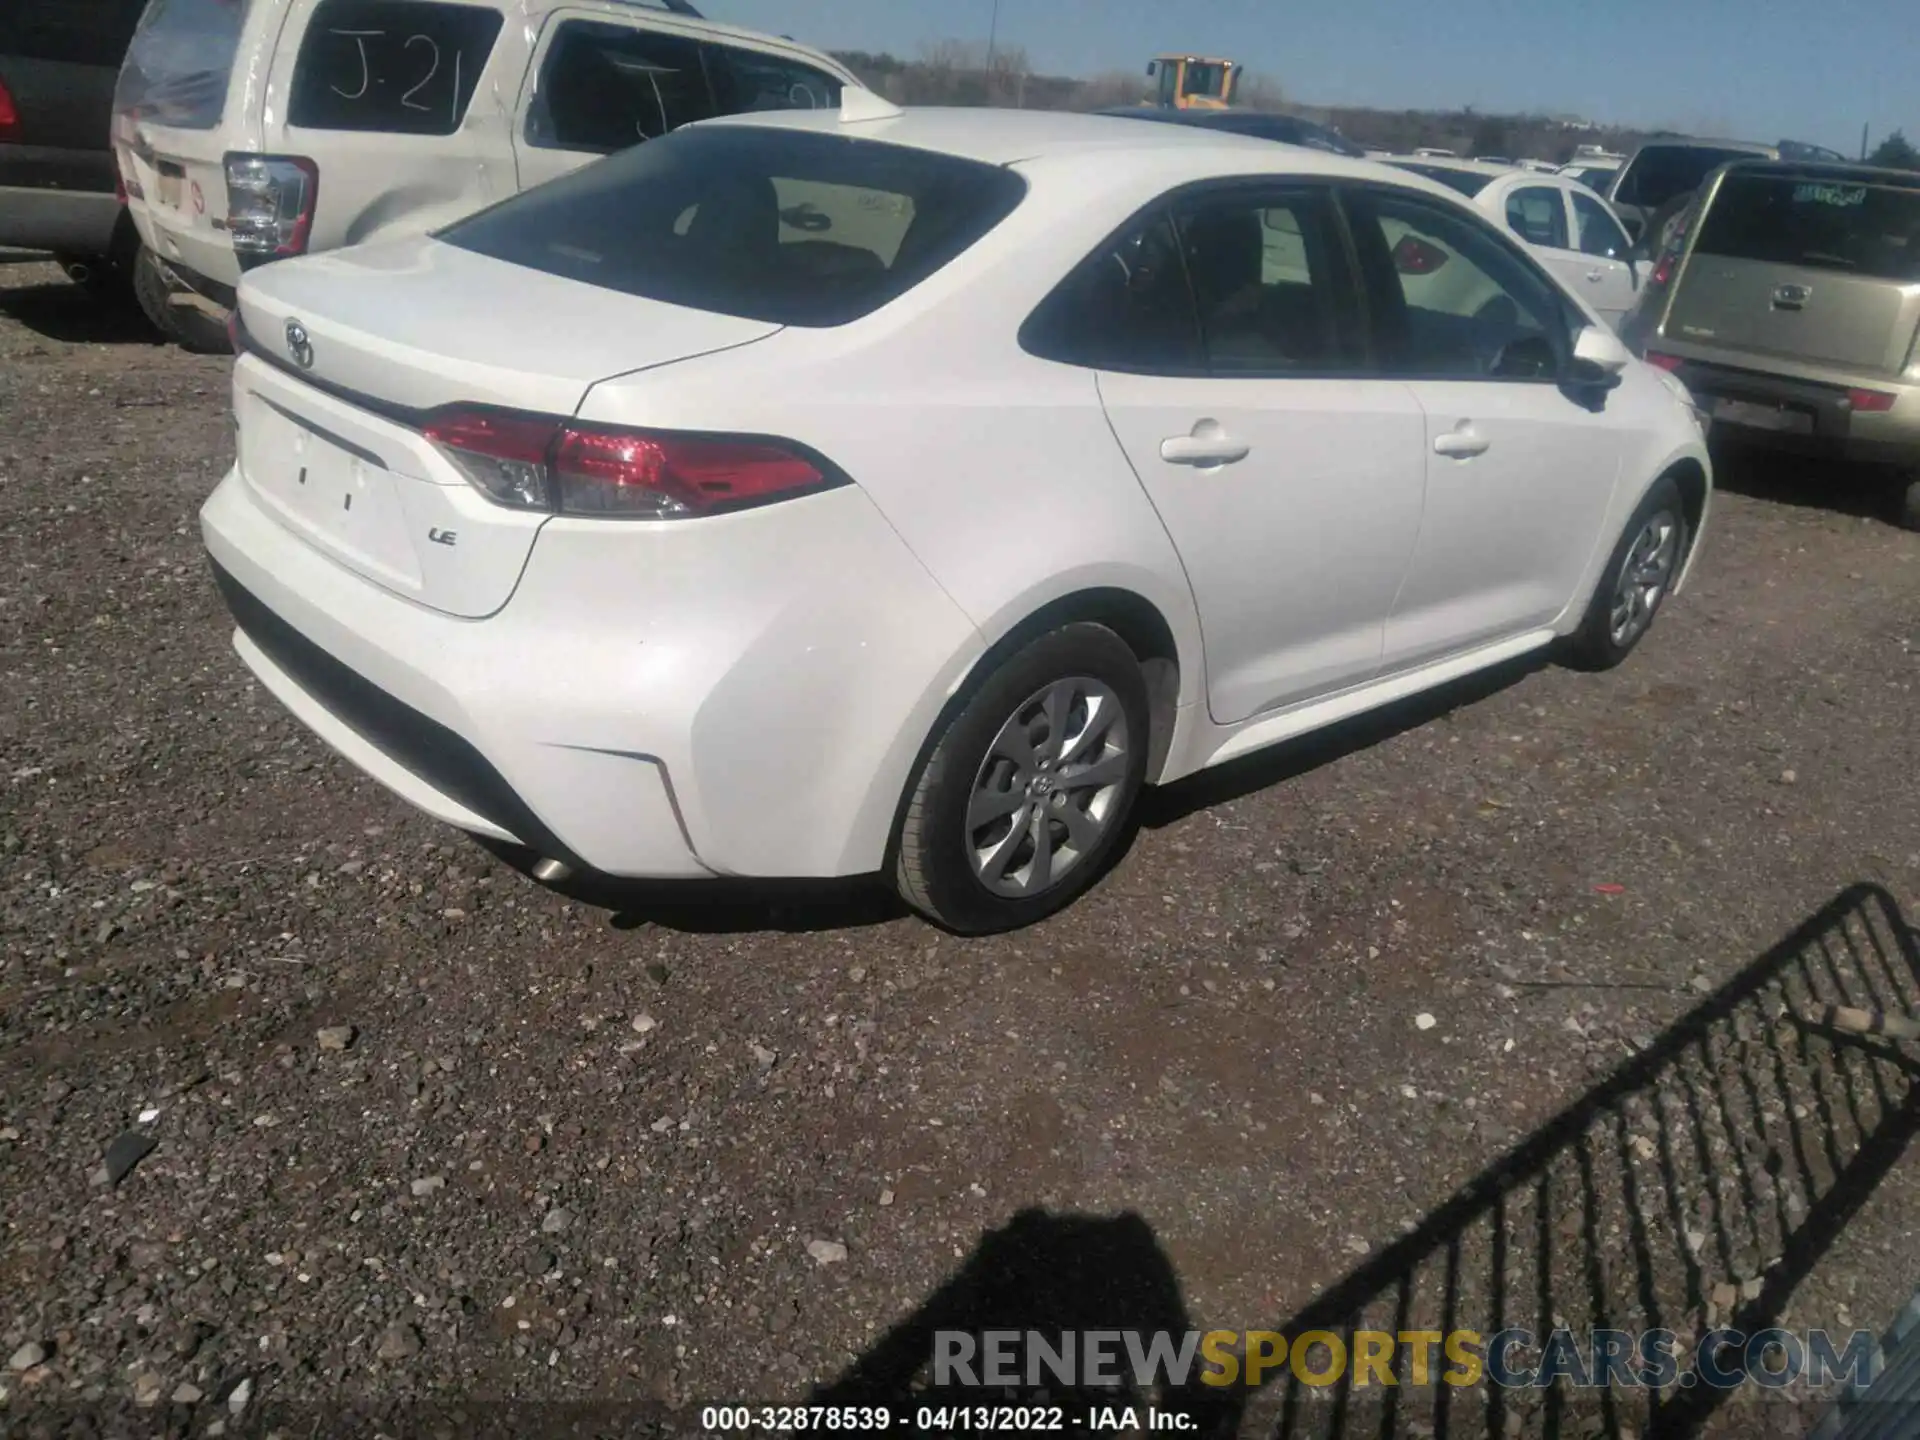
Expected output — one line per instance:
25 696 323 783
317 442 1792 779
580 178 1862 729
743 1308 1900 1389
234 238 780 616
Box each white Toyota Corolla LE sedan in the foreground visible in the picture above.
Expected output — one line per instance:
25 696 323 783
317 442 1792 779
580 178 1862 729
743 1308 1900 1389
202 90 1711 931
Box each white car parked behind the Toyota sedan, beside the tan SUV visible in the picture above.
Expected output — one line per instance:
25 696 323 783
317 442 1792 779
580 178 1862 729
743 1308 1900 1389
1388 159 1640 330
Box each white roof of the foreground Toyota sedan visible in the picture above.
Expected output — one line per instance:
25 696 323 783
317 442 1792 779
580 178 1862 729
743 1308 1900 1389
701 106 1375 175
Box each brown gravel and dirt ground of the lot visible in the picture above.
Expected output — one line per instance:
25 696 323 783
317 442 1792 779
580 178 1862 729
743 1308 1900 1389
0 253 1920 1434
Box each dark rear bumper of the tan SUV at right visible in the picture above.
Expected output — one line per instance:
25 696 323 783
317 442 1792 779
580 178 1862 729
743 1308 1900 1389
1674 359 1920 465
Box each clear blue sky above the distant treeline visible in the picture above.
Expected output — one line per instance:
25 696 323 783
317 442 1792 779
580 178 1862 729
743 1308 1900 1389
714 0 1920 154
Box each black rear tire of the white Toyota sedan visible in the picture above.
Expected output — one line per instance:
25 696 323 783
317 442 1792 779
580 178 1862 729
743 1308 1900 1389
893 624 1148 935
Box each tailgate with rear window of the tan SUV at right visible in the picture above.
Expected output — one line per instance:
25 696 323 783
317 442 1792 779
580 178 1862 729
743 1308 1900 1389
1665 171 1920 374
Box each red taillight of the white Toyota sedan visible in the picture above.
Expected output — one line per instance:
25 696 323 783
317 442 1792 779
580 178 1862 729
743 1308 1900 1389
424 405 845 520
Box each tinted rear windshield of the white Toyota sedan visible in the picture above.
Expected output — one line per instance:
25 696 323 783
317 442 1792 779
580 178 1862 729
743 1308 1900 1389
440 125 1025 326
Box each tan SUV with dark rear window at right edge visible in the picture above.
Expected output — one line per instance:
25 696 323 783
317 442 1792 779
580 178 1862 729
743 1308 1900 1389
1620 161 1920 530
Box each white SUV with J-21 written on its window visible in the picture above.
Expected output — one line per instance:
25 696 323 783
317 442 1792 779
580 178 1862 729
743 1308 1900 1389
113 0 858 348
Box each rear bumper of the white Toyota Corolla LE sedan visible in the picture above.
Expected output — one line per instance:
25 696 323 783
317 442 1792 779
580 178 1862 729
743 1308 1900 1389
202 472 979 879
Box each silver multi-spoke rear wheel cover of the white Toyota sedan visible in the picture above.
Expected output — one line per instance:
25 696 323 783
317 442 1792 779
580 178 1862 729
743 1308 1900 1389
966 676 1129 899
